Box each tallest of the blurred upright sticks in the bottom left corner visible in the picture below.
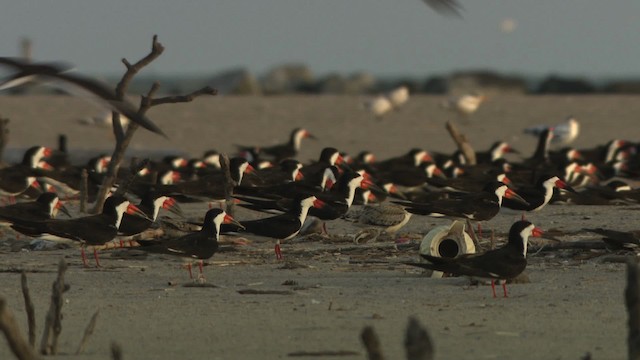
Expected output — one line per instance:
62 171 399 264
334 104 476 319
40 259 67 355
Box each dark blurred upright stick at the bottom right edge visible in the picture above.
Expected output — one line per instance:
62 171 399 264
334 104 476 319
624 259 640 360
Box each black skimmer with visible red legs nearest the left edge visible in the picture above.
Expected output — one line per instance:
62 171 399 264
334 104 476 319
12 196 146 266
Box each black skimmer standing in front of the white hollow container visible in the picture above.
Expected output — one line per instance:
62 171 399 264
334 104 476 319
407 220 542 298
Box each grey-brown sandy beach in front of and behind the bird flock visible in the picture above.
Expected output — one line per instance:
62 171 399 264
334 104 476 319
0 95 640 359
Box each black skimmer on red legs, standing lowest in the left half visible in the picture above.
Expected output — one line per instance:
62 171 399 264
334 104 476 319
138 208 241 280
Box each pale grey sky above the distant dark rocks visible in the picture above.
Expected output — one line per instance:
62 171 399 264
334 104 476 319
0 0 640 78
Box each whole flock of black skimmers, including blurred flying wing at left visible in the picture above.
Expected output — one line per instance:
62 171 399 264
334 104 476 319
0 58 640 296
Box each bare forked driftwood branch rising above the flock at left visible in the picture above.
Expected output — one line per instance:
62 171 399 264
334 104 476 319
92 35 217 213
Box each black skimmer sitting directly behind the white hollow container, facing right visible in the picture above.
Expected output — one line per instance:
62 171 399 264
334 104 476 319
393 181 526 221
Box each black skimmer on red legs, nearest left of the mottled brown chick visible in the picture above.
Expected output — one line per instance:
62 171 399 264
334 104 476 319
240 196 325 259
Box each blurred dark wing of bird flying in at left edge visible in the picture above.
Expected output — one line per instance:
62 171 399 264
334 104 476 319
0 57 166 137
